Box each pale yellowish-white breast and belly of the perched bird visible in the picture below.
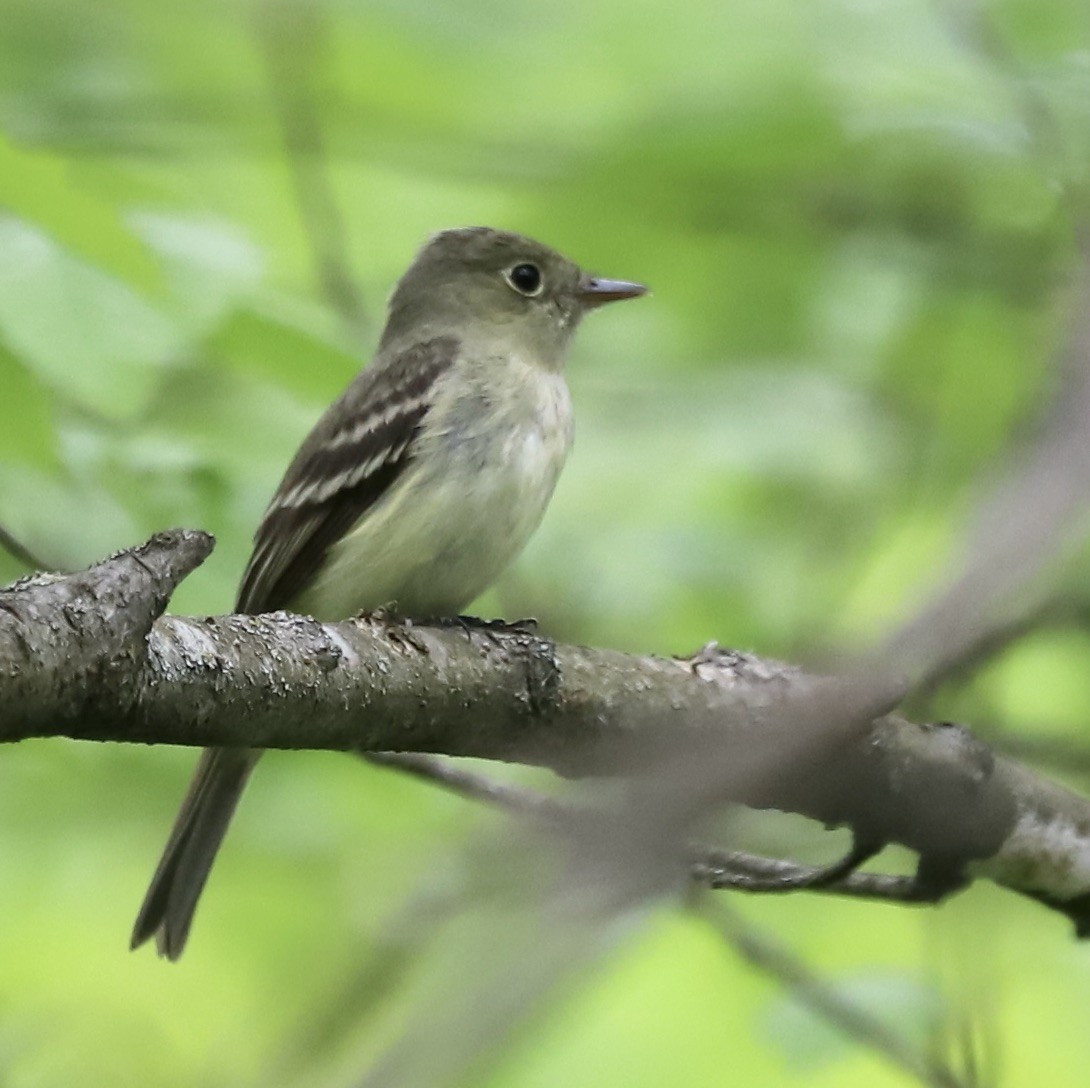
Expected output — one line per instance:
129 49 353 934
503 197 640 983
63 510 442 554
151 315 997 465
298 359 572 616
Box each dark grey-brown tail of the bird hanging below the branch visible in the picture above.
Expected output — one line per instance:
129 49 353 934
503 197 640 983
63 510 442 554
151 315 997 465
131 748 261 959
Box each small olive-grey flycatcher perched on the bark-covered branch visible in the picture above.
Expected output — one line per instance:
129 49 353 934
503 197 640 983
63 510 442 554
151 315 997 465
131 227 647 960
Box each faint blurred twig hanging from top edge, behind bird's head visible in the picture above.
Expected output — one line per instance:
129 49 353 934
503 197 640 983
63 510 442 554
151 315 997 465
257 0 365 335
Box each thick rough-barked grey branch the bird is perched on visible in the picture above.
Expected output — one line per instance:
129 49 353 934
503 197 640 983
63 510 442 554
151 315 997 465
6 531 1090 933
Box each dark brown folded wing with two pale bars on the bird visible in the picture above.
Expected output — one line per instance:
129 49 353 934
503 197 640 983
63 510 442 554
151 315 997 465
235 337 459 613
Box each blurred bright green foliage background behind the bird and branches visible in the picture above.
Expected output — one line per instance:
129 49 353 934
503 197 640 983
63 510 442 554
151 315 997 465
0 0 1090 1088
